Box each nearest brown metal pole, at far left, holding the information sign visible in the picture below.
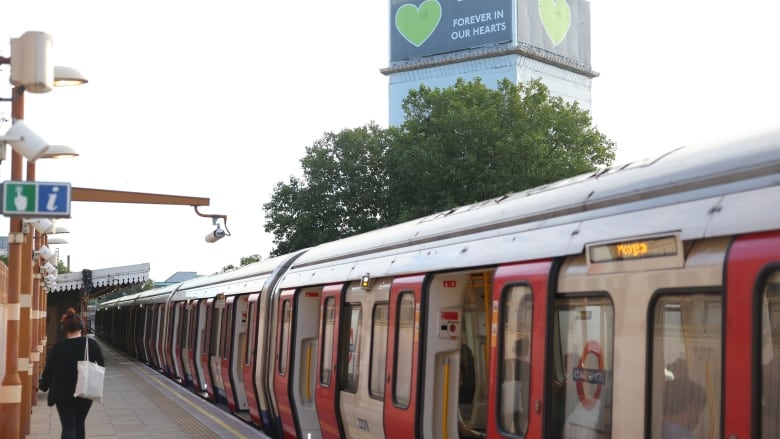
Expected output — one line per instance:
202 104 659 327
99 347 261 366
0 86 24 438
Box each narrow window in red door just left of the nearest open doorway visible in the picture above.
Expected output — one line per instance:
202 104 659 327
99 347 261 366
393 292 414 408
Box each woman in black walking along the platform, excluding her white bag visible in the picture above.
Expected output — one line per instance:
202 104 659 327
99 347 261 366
38 308 105 439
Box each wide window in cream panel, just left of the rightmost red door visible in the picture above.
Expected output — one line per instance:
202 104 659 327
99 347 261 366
650 293 723 439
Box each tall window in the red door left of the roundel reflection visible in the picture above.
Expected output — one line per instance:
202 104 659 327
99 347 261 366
498 285 533 435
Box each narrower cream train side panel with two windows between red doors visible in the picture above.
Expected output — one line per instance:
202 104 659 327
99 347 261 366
338 278 391 439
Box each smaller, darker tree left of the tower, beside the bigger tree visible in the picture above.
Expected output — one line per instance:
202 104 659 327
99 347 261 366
263 122 391 255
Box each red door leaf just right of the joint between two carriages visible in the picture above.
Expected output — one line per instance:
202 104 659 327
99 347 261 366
273 290 297 439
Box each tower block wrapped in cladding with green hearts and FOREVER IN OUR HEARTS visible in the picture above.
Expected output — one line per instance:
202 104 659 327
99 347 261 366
382 0 598 125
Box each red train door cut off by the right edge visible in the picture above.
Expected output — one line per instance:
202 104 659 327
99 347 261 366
723 232 780 439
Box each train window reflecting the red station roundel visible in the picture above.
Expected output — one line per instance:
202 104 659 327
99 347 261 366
549 295 614 439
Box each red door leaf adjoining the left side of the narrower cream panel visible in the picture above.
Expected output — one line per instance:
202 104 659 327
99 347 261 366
315 284 343 439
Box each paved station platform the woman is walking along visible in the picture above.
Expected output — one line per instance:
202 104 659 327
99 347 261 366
27 339 268 439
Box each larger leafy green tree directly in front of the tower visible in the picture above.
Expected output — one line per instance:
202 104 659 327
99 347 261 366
386 79 615 223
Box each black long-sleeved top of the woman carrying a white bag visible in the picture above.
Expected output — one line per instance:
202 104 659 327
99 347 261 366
38 337 105 406
